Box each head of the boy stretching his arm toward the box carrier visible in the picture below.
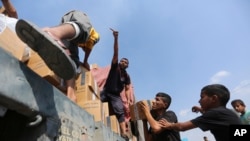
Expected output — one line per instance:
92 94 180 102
199 84 230 111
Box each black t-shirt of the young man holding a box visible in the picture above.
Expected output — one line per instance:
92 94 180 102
149 111 181 141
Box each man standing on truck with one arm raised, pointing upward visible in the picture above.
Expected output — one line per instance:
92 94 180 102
101 29 130 139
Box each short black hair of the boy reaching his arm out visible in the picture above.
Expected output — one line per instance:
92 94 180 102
201 84 230 106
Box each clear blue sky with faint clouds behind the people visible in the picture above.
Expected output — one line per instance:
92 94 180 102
8 0 250 141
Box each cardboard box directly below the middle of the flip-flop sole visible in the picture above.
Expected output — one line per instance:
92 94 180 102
27 51 61 87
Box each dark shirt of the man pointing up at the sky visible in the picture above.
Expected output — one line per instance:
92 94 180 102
104 62 130 94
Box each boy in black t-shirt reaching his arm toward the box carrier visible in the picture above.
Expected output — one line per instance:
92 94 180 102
160 84 241 141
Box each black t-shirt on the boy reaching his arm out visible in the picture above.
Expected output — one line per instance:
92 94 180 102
191 106 241 141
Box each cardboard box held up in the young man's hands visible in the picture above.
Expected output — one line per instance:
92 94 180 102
129 100 153 121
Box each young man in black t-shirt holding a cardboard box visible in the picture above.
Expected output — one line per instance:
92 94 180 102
139 92 181 141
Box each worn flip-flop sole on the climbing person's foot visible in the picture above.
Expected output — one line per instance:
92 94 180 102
16 19 76 80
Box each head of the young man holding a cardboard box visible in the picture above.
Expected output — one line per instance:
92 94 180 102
152 92 171 110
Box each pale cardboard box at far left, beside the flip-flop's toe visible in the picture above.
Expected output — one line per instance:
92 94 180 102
0 26 31 62
